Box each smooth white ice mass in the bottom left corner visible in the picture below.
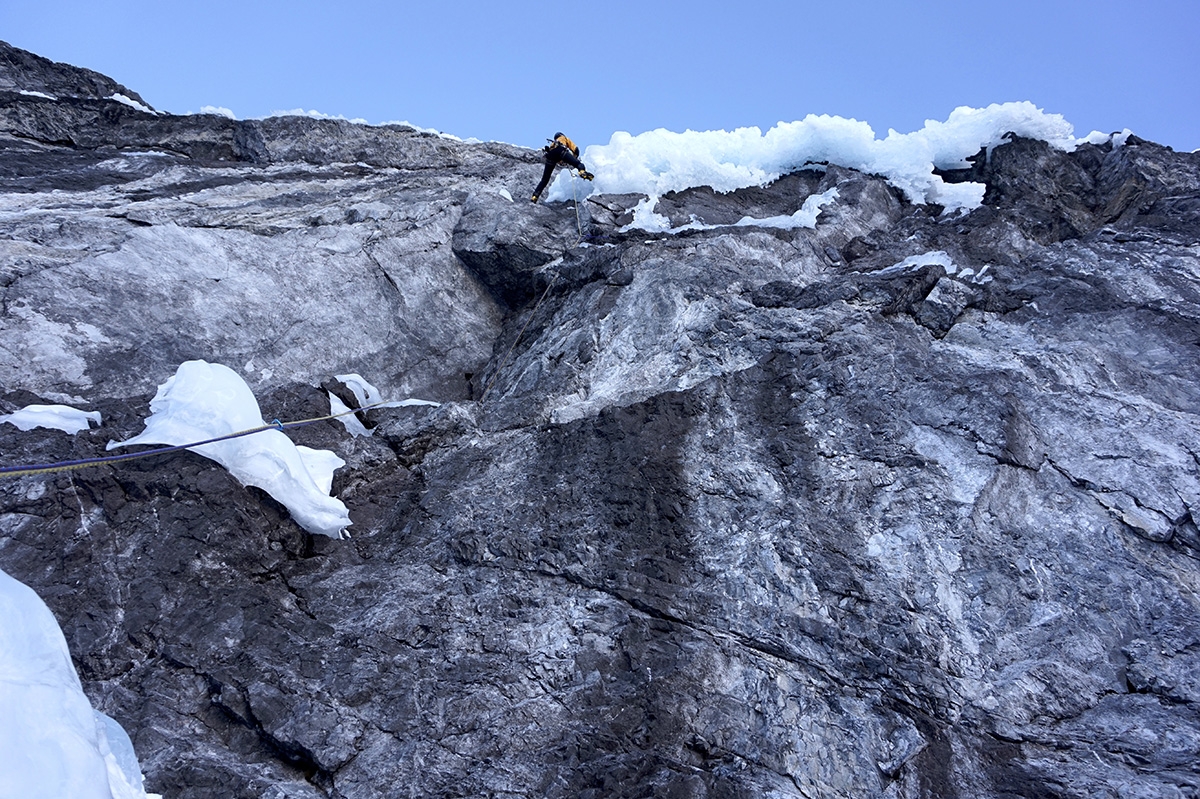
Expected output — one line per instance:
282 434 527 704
0 570 146 799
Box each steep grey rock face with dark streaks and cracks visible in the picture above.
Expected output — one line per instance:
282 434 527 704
0 48 1200 799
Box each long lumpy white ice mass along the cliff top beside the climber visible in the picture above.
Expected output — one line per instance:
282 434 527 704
546 102 1109 211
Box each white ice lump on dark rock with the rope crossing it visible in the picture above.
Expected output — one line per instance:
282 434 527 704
108 361 350 539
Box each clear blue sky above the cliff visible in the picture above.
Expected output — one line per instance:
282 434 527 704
0 0 1200 150
